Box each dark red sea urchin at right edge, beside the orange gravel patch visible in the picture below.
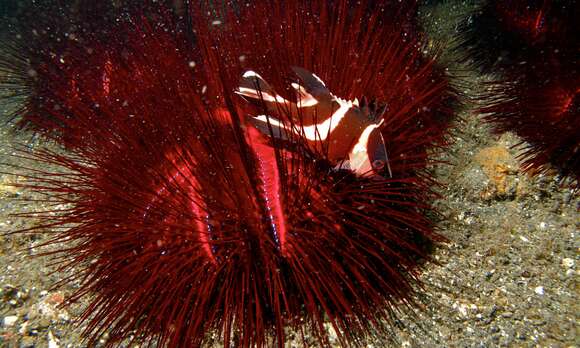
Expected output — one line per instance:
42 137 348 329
479 70 580 179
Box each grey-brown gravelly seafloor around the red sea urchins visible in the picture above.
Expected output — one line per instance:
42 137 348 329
0 1 580 348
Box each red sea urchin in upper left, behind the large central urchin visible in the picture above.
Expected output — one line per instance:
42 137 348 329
0 0 181 141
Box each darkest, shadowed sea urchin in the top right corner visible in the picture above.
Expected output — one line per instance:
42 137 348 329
461 0 579 74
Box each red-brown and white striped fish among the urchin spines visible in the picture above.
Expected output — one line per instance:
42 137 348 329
236 67 392 177
